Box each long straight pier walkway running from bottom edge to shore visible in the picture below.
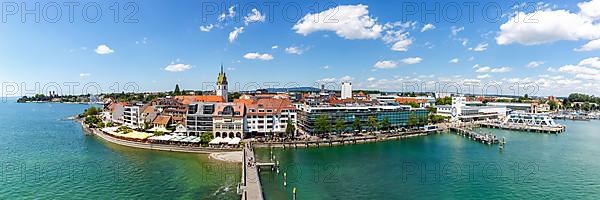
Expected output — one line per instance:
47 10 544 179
238 143 264 200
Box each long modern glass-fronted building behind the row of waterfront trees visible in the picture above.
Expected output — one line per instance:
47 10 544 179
298 105 429 134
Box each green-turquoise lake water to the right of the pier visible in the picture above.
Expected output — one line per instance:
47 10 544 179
257 120 600 199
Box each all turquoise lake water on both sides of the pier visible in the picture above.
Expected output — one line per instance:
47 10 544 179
0 103 600 200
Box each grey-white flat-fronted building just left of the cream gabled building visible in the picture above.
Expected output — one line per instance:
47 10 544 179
186 102 216 136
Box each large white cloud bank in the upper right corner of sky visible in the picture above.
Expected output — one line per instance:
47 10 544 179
496 7 600 45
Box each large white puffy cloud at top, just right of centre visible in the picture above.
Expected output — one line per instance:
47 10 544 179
292 4 383 39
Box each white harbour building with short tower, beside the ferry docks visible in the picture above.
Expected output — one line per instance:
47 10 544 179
437 96 507 121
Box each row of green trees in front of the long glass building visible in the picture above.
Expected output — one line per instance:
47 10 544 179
315 113 429 134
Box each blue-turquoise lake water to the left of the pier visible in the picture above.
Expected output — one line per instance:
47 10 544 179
0 102 241 199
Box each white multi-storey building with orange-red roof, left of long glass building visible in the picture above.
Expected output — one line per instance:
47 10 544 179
234 94 297 136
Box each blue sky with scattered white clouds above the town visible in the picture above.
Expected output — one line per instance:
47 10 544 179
0 0 600 96
